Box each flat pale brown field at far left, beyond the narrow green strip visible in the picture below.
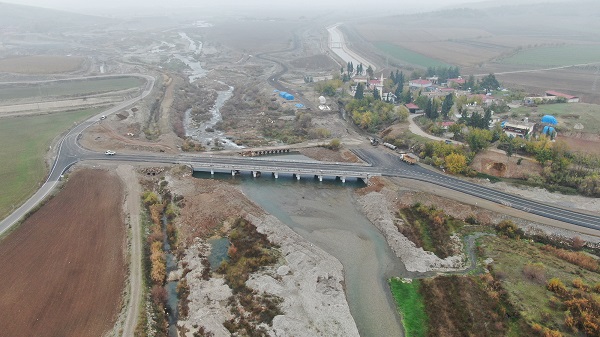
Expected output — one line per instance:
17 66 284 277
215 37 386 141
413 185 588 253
0 56 85 74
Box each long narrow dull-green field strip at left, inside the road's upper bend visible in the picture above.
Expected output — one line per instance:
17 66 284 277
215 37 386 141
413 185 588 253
0 77 144 100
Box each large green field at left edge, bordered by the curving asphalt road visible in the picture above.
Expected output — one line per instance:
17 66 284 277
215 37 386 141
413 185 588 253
0 108 101 219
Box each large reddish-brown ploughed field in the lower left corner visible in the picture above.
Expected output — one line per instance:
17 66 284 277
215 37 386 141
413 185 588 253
0 170 125 337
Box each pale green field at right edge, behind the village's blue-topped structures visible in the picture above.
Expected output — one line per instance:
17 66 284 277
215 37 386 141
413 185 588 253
510 103 600 134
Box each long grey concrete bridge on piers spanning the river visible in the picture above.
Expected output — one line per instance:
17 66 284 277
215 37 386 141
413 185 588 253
189 161 381 183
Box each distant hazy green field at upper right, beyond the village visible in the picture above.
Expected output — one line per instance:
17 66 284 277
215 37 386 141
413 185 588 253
500 45 600 67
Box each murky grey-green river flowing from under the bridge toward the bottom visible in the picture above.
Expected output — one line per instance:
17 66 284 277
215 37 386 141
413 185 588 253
194 156 416 337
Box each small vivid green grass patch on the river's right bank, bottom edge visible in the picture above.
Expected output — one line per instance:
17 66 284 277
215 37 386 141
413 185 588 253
389 278 427 337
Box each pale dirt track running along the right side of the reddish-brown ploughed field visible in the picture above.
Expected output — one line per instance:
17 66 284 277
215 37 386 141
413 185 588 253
117 165 142 337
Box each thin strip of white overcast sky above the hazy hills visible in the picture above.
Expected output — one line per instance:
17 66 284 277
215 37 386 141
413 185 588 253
0 0 542 15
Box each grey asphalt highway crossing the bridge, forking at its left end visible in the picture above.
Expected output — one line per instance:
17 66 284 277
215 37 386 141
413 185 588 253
0 75 600 235
